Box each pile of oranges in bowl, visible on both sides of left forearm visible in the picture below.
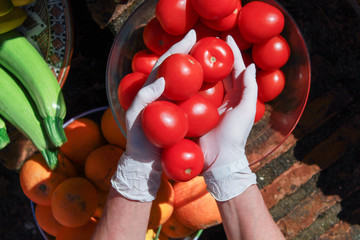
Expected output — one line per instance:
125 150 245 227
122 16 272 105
20 108 221 240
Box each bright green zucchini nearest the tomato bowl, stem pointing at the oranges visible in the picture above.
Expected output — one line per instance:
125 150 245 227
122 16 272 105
0 30 66 146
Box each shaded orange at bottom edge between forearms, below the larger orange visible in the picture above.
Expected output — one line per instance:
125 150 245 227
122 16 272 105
161 214 196 238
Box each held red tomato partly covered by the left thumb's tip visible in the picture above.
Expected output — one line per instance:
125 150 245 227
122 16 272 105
157 53 204 101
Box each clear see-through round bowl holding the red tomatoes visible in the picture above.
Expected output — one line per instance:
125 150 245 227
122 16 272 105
106 0 311 165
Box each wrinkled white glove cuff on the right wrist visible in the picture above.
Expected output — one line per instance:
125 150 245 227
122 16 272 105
203 162 257 201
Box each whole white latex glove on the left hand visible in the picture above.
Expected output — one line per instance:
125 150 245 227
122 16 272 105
111 30 196 202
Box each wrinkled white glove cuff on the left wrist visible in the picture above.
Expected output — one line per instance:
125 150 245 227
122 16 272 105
111 153 162 202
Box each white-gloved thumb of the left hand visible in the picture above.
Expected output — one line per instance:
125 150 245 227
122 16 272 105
126 77 165 125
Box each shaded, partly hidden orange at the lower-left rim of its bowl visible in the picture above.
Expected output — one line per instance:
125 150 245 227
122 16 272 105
35 205 61 237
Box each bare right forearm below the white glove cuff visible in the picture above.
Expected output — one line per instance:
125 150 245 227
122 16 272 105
218 185 285 240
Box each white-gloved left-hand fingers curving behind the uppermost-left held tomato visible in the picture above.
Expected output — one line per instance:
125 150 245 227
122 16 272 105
145 29 196 86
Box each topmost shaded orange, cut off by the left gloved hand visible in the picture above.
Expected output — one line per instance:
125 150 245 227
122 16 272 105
100 108 126 149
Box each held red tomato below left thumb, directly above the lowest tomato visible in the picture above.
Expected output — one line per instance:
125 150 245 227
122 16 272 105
141 101 189 148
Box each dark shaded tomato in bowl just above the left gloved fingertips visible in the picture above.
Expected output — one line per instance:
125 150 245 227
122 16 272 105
143 18 183 55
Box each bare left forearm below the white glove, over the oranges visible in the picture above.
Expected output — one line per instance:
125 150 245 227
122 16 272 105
92 188 152 240
